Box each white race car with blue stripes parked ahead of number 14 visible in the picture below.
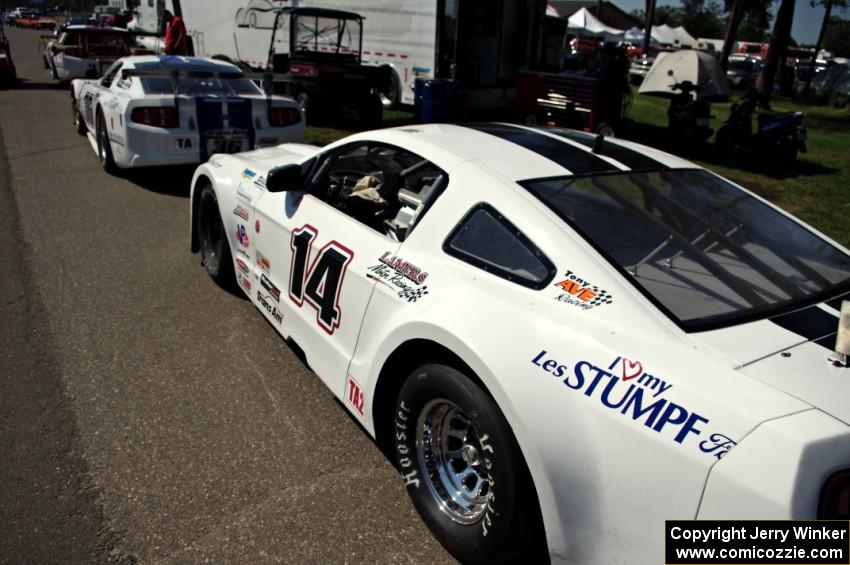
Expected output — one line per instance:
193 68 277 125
71 55 304 172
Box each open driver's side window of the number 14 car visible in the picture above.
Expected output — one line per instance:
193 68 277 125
309 142 448 241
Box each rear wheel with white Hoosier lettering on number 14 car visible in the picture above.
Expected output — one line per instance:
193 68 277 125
393 364 545 563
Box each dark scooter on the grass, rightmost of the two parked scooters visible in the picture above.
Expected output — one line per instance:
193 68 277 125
714 91 806 162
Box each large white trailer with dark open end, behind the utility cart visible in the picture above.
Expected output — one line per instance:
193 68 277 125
134 0 546 105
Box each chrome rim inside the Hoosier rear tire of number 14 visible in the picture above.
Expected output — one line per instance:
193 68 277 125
416 399 490 524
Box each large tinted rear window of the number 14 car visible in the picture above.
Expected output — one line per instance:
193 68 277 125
522 170 850 331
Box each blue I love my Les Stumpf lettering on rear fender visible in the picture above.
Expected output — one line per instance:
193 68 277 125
531 350 737 459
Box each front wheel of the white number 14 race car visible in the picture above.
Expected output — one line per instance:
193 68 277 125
196 182 236 290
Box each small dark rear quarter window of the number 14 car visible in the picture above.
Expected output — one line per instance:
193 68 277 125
443 203 555 290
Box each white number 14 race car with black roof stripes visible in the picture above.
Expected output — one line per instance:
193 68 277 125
191 124 850 565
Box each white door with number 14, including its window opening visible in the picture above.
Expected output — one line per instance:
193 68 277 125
247 142 434 406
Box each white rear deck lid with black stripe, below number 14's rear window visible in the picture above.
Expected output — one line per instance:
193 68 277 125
693 304 850 425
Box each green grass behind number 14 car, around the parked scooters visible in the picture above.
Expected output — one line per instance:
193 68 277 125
305 89 850 247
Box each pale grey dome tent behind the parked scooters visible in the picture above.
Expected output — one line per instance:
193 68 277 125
638 49 729 99
